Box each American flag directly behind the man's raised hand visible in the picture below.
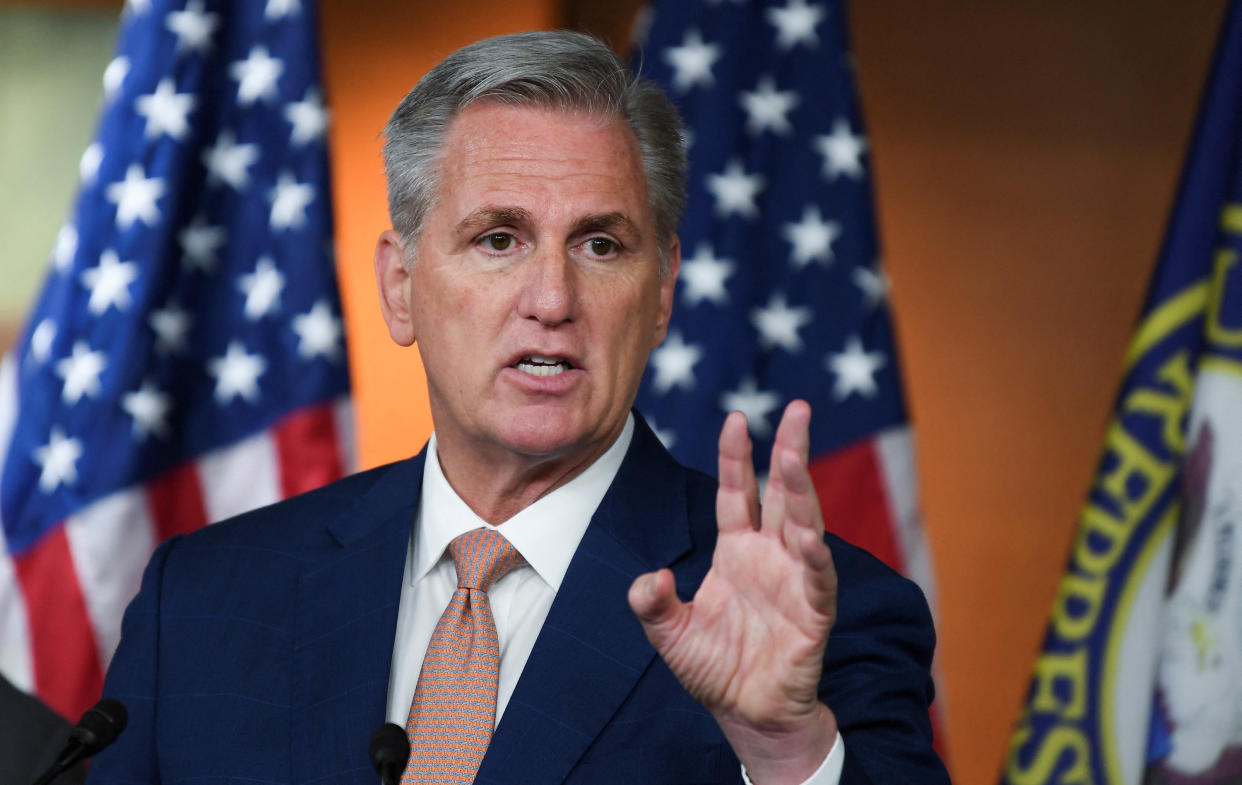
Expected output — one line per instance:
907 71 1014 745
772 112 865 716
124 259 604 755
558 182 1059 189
636 0 943 750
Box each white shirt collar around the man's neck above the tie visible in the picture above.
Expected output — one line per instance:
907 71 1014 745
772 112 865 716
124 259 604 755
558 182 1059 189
410 414 633 591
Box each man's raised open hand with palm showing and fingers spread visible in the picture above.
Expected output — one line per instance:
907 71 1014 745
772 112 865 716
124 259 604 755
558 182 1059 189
630 401 837 785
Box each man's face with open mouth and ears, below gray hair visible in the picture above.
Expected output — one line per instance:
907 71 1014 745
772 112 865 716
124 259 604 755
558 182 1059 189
376 103 679 471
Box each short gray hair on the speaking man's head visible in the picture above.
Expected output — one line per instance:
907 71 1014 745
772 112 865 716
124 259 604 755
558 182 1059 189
384 30 686 273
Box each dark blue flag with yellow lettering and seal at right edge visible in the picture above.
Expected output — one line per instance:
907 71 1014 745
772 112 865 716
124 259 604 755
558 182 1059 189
1002 2 1242 785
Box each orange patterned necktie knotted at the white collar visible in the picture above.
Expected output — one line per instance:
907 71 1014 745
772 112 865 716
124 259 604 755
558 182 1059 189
401 529 523 785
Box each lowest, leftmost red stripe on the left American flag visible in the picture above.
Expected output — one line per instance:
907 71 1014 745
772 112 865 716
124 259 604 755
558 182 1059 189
16 524 103 717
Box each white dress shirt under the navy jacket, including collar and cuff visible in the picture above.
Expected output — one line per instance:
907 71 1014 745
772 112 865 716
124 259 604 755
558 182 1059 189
388 415 845 785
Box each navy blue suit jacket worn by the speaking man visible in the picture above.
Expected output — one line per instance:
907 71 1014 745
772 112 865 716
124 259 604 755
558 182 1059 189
89 419 949 785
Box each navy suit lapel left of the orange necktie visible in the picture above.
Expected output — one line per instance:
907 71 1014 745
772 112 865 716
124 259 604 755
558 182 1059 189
292 453 424 783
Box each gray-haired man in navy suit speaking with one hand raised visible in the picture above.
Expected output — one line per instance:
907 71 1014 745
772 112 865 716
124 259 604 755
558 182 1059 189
92 27 948 785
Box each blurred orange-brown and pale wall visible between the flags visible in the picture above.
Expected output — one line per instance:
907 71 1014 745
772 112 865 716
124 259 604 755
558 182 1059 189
0 0 1225 785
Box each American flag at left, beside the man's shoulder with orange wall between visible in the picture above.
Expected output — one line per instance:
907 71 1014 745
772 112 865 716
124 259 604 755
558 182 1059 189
0 0 351 718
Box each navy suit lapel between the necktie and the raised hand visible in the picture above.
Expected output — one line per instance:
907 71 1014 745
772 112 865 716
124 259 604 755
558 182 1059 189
474 415 691 785
